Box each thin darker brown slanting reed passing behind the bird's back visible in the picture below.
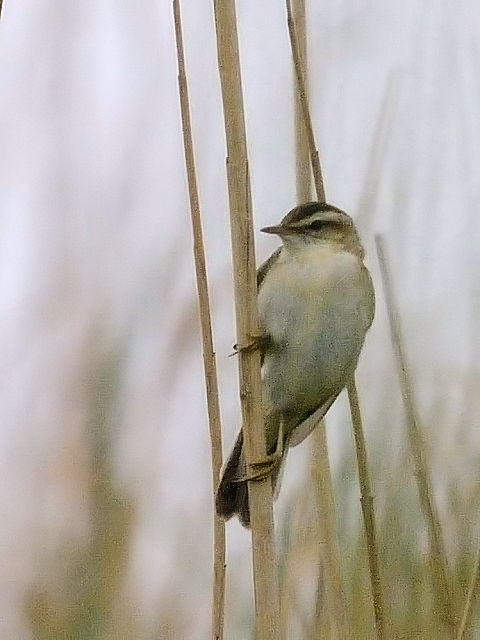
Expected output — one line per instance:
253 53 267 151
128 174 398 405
286 0 385 639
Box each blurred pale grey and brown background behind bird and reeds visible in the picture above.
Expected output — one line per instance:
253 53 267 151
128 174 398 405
0 0 480 640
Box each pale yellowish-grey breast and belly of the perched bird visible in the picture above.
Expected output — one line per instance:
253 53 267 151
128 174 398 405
259 250 367 416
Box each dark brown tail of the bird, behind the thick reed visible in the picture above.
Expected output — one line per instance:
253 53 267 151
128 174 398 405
215 430 285 527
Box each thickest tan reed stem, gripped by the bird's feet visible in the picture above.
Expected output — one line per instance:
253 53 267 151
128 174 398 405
214 0 280 640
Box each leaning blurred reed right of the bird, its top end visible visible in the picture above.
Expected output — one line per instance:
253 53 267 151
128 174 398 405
375 235 457 635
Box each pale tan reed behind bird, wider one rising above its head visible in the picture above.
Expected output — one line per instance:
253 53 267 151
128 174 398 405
293 0 350 640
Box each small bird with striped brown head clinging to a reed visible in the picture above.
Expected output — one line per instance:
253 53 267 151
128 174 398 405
215 202 375 527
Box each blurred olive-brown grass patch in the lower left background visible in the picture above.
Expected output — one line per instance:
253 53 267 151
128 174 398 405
26 349 135 640
